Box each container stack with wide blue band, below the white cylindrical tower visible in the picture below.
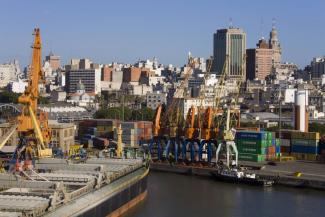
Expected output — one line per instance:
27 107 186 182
291 131 320 161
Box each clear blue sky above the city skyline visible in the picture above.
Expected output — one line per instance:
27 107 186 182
0 0 325 67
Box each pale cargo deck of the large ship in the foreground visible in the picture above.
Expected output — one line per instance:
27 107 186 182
0 158 146 217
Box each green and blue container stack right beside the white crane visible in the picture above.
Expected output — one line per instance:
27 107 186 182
235 131 280 162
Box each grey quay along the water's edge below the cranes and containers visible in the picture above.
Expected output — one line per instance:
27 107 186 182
150 161 325 190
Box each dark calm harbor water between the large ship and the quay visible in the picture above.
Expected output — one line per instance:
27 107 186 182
123 171 325 217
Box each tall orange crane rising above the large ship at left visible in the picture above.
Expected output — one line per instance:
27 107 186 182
17 28 52 157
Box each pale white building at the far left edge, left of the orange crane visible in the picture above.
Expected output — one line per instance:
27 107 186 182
0 60 21 87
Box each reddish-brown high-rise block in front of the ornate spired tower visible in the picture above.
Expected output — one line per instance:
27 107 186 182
246 38 273 80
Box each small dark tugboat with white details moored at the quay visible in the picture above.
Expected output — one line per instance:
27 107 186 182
211 166 274 187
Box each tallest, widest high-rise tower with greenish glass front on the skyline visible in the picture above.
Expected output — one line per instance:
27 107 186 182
213 28 246 80
